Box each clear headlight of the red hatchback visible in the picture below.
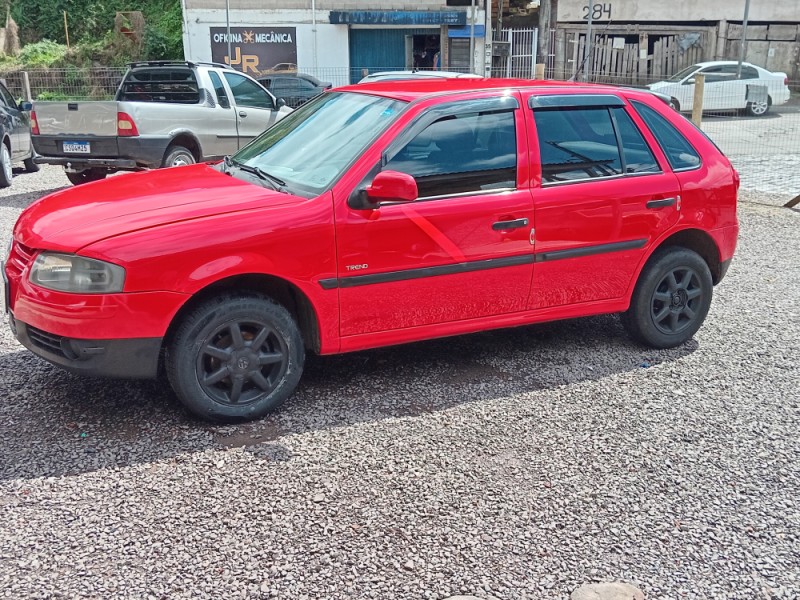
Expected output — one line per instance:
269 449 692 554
30 252 125 294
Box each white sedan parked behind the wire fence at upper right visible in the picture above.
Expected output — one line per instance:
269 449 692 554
647 60 789 117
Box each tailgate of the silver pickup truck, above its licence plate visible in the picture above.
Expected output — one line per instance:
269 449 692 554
33 101 117 137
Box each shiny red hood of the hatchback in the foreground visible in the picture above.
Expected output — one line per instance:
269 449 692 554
14 164 305 252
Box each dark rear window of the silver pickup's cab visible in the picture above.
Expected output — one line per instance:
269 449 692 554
118 67 200 104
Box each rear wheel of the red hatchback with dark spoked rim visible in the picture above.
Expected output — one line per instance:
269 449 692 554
622 246 714 348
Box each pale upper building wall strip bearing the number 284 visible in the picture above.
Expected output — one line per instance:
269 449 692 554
558 0 800 23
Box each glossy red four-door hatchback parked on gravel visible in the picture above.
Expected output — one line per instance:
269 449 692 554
3 79 738 420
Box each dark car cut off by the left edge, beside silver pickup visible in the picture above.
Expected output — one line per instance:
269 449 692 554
0 83 39 188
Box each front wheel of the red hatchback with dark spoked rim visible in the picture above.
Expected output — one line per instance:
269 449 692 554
166 293 305 422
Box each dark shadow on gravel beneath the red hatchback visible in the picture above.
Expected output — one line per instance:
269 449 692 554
0 316 697 480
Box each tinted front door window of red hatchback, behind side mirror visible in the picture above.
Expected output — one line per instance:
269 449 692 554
384 111 517 198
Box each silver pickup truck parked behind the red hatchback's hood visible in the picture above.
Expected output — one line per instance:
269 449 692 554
31 61 292 185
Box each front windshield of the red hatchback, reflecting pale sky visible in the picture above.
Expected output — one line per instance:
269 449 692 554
233 92 406 197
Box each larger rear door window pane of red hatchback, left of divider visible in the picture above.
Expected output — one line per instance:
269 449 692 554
533 107 622 183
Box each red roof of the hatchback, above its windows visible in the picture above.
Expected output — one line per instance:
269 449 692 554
335 78 652 102
